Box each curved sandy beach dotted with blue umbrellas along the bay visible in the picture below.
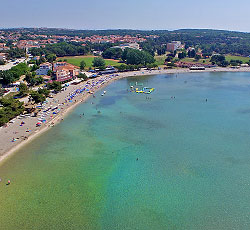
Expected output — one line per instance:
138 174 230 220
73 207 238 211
0 67 250 163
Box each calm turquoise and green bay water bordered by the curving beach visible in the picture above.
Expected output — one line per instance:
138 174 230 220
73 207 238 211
0 73 250 230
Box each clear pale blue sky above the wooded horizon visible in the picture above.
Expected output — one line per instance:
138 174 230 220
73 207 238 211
0 0 250 32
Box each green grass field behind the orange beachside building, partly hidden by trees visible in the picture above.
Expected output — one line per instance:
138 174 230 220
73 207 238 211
58 56 121 68
